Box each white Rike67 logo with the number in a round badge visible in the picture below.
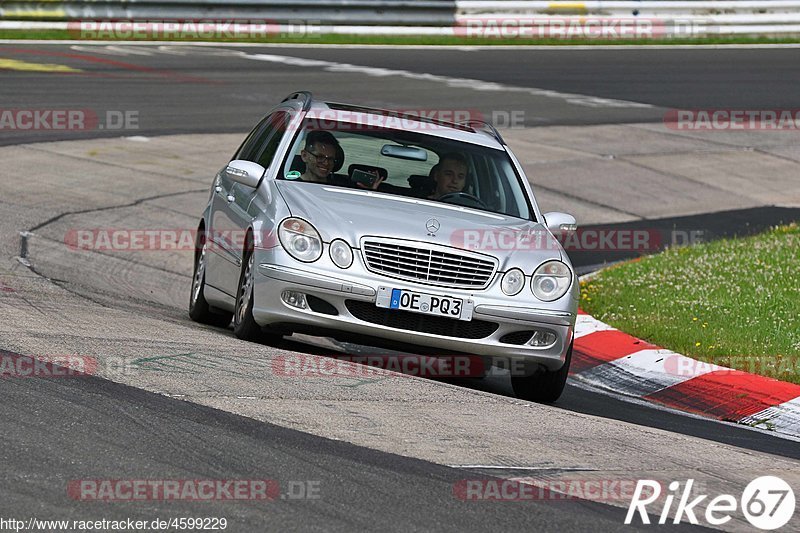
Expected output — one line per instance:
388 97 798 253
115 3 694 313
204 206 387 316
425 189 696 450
625 476 795 531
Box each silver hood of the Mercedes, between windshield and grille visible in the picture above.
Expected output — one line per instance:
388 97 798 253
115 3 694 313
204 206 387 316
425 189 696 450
277 181 563 274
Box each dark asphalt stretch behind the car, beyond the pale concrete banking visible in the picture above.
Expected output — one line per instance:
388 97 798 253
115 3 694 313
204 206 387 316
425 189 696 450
0 43 800 144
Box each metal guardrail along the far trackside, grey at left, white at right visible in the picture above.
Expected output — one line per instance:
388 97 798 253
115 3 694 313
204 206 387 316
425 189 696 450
0 0 800 38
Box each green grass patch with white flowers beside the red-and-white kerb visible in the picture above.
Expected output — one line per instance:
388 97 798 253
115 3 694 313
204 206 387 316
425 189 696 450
581 223 800 383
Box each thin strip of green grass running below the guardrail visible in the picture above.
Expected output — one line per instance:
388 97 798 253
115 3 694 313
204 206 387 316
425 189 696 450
0 30 800 46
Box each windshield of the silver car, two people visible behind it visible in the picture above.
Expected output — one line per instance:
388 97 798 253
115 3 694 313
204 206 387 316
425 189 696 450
278 119 533 219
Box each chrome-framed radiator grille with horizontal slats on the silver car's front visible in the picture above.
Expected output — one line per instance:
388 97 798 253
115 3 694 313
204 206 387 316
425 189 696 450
362 239 496 289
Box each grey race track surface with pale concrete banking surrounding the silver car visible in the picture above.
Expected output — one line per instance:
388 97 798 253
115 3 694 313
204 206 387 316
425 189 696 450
0 43 800 531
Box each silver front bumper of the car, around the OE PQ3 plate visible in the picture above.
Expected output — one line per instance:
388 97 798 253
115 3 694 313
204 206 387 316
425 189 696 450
253 248 577 370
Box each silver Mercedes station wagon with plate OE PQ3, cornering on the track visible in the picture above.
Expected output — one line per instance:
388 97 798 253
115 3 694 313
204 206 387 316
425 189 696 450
194 92 579 402
